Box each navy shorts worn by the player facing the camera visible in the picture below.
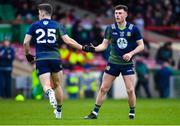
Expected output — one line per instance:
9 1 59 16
105 63 135 77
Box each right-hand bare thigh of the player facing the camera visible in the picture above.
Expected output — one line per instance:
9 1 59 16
123 74 136 90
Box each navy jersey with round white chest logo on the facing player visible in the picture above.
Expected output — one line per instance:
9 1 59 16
104 23 142 64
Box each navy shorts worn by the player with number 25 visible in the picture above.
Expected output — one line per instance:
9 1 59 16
36 60 63 76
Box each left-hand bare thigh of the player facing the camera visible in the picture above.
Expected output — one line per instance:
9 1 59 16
101 72 116 89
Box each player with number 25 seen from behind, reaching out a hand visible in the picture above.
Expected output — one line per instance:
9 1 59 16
24 3 84 119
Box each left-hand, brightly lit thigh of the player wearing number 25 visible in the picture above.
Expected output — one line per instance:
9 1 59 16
39 72 51 86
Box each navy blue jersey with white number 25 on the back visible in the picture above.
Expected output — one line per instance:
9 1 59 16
27 19 67 60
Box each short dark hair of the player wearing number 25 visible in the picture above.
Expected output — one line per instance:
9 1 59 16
38 3 53 15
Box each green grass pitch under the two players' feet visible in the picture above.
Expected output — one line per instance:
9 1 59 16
0 99 180 125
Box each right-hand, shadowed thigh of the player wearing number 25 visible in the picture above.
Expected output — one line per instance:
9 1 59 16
51 70 63 86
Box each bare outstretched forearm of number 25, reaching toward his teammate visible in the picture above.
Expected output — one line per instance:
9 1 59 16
61 34 82 50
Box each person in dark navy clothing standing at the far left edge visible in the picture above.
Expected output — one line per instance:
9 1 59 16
0 40 15 98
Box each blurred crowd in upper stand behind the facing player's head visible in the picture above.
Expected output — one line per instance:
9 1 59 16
60 0 180 26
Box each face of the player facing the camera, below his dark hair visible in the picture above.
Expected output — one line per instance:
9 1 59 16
114 9 127 23
